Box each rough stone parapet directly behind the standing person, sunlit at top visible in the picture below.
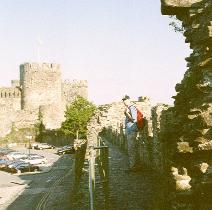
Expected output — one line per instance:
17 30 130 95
87 97 153 167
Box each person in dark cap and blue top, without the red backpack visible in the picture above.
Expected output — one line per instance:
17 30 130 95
122 95 140 172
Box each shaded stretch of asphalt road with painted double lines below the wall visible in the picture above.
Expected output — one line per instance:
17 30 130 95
7 155 74 210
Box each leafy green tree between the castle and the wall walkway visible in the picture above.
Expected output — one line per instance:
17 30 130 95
61 96 96 138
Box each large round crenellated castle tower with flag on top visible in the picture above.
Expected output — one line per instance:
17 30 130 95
20 63 61 110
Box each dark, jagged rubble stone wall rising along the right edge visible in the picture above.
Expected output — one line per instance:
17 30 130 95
161 0 212 209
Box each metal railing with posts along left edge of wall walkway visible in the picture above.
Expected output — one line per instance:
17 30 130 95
89 137 109 210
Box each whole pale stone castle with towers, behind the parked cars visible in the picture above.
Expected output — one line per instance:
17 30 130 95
0 63 88 137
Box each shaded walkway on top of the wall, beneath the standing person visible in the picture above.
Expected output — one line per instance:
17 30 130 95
72 139 163 210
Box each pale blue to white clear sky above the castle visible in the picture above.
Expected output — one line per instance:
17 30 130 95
0 0 190 104
